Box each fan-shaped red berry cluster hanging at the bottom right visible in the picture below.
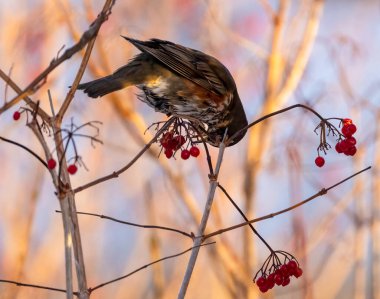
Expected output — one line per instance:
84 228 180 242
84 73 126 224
253 251 303 293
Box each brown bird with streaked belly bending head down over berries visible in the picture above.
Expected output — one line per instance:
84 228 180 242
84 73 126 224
78 36 248 147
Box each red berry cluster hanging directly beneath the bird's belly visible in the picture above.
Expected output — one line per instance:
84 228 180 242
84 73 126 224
159 131 200 160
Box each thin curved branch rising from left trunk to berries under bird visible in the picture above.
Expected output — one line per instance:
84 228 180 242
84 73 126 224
74 118 175 193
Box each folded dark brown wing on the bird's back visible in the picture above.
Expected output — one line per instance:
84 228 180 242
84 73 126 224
123 36 226 95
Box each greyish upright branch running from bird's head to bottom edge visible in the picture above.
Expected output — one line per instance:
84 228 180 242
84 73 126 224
178 137 227 298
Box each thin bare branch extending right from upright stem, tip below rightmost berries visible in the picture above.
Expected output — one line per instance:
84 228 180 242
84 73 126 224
203 166 371 240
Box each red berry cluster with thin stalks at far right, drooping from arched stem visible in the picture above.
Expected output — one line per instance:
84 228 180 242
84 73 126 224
315 118 357 167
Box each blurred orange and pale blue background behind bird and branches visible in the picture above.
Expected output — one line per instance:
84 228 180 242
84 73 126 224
0 0 380 299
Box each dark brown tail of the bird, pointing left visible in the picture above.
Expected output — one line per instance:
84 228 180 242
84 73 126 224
78 75 126 98
